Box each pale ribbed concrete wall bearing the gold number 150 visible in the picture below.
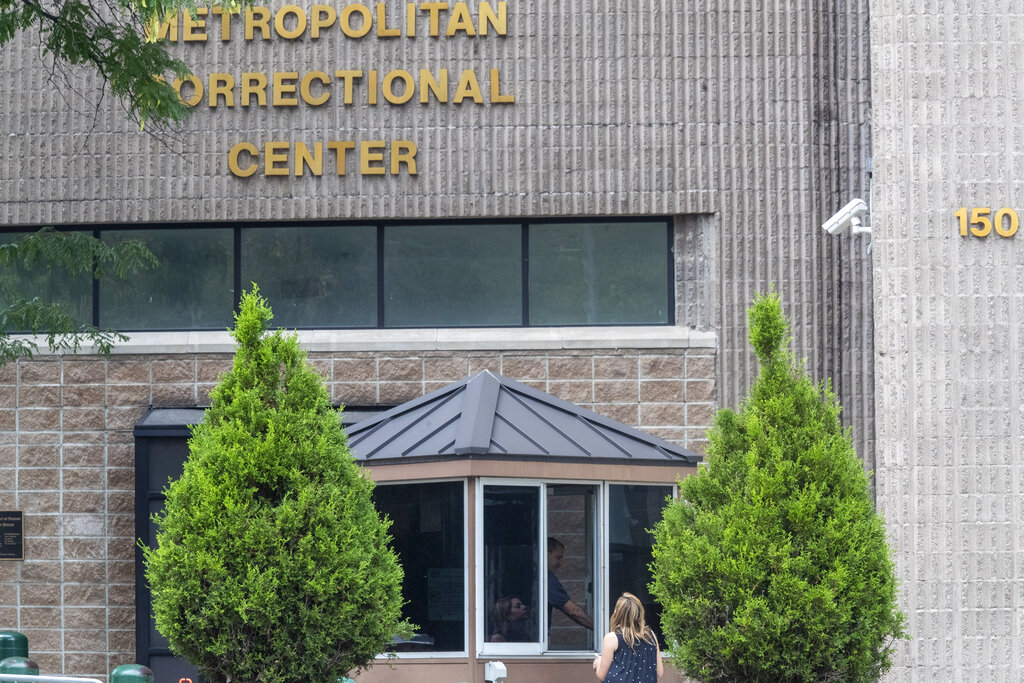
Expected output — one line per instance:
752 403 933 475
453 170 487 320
871 0 1024 681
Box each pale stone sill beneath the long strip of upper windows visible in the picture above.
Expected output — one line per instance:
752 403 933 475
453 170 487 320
12 326 718 355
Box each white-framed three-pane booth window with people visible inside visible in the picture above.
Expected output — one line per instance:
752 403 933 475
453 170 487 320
477 480 673 656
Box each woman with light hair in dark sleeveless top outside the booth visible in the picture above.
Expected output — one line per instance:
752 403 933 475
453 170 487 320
594 593 664 683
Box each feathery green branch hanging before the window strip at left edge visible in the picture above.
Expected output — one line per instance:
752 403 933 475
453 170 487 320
0 227 158 366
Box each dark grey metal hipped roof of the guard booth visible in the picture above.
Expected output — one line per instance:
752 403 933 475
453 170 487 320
347 370 700 465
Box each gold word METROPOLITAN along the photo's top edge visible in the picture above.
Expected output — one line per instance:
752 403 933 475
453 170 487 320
146 2 508 43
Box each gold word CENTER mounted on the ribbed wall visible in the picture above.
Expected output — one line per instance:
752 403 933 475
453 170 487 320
227 140 418 178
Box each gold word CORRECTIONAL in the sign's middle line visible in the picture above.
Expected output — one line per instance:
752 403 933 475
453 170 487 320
173 69 515 108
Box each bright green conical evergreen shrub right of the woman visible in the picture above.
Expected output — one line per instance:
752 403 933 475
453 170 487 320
651 294 906 683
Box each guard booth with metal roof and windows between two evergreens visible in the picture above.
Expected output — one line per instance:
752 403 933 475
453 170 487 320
348 371 699 683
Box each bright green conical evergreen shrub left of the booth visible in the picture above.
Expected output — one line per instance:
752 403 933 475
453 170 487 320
143 290 410 683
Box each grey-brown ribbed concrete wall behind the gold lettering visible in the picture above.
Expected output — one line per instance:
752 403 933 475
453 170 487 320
0 0 872 461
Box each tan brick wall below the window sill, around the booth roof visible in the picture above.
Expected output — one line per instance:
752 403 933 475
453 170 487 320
0 349 716 676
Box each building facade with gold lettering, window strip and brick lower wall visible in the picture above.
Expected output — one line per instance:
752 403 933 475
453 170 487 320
0 0 879 680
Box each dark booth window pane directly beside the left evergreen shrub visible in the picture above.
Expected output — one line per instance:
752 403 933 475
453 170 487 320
374 481 466 652
